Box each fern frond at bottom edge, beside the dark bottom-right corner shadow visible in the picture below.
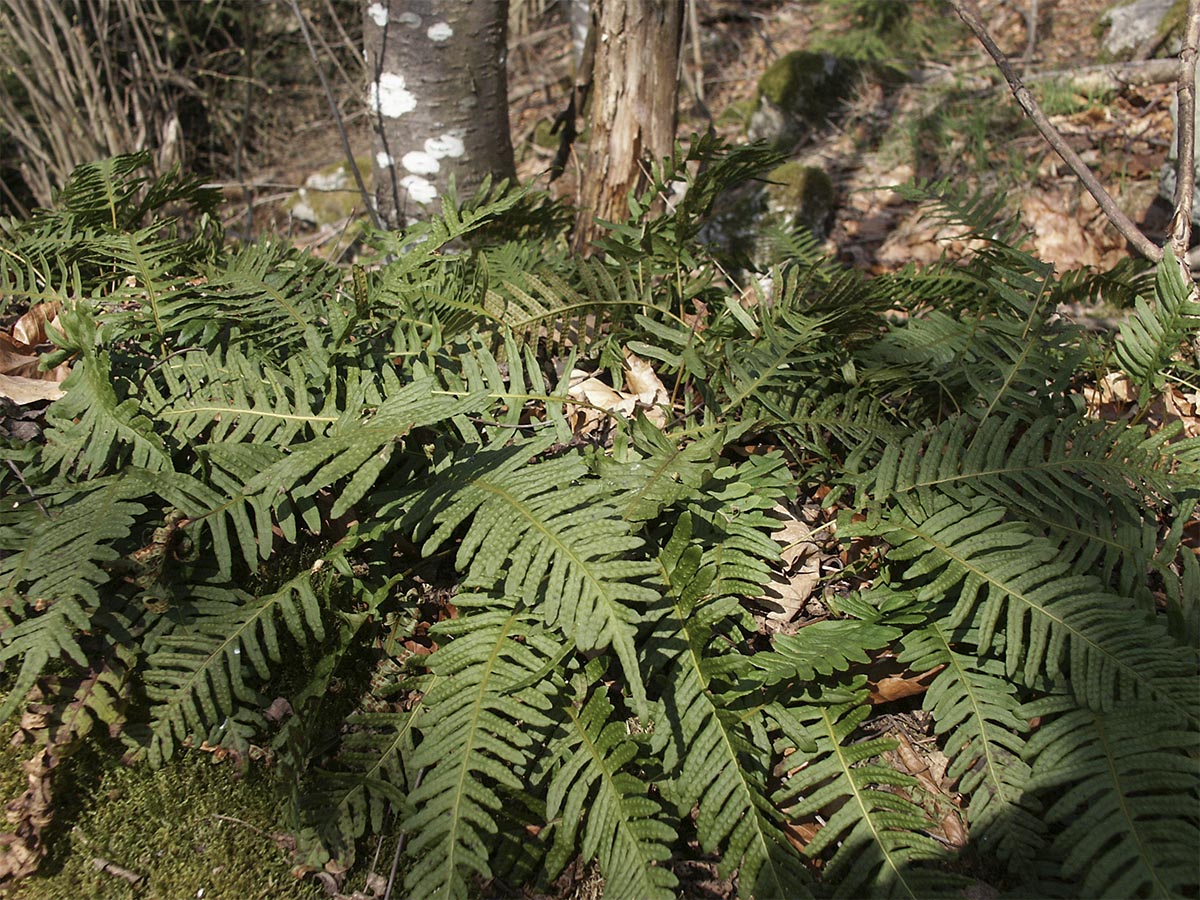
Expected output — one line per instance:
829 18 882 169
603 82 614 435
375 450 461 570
775 679 961 899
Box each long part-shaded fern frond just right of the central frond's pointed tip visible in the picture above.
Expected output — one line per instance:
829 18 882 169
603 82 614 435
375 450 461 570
655 514 809 898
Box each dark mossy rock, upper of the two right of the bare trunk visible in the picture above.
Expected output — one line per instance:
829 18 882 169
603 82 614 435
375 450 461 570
746 50 859 151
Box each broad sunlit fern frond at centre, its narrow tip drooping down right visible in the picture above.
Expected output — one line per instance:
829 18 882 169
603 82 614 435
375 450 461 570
404 437 659 712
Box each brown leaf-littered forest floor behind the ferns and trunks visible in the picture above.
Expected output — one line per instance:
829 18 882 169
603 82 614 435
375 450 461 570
243 0 1174 289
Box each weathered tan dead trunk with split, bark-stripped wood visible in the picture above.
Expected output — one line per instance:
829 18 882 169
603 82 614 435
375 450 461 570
575 0 684 252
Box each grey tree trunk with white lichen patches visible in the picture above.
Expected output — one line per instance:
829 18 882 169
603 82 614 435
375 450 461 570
364 0 515 228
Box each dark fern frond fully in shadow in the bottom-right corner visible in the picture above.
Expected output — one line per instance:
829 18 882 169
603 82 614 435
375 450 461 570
1020 696 1200 898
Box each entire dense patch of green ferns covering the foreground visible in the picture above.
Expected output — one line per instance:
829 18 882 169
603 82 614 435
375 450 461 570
0 151 1200 898
